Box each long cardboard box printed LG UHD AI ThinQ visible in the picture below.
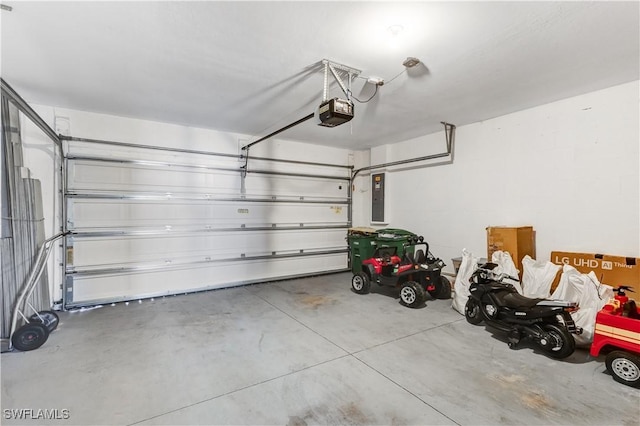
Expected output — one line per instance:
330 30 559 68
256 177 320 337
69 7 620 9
551 251 640 292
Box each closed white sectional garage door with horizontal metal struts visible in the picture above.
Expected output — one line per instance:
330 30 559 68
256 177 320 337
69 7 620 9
64 138 350 308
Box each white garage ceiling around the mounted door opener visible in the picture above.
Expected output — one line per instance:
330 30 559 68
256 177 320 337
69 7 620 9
0 1 640 149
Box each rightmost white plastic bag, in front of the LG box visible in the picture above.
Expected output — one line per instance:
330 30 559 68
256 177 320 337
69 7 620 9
551 265 613 346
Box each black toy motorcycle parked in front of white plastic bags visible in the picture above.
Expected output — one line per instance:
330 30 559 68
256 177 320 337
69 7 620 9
464 263 582 359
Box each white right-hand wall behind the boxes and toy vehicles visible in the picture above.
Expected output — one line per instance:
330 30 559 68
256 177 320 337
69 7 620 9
354 81 640 268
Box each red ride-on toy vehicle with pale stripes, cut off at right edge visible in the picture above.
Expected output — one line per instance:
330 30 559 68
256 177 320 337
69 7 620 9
590 285 640 388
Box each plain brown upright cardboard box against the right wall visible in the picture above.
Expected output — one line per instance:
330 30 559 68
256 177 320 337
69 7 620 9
487 226 536 276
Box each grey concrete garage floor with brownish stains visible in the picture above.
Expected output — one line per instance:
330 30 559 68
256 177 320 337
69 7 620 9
1 273 640 425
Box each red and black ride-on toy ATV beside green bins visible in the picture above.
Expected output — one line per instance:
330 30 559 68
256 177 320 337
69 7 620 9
351 237 451 308
